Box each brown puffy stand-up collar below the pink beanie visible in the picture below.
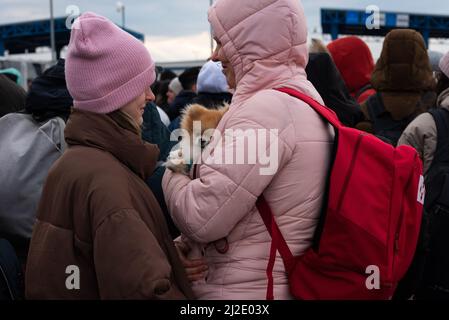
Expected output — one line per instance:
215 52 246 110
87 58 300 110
64 110 159 180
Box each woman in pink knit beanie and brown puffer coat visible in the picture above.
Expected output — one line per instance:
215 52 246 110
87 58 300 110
26 13 192 299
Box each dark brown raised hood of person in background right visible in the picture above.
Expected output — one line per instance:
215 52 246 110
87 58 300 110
371 29 435 92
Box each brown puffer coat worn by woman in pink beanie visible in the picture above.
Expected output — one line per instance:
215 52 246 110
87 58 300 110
26 111 192 299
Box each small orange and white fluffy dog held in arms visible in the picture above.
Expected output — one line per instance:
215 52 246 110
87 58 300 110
165 104 229 175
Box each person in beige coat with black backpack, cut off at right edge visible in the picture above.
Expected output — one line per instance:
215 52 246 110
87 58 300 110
399 52 449 300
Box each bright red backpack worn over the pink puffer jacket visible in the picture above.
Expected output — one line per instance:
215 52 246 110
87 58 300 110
257 88 425 300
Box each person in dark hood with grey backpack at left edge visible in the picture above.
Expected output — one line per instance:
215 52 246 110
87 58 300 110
0 59 73 265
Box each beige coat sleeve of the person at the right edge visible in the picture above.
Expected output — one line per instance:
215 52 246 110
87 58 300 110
398 113 437 173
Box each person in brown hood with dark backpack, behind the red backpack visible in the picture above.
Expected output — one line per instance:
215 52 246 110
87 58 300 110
356 29 436 146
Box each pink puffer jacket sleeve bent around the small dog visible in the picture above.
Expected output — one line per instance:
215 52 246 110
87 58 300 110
162 114 294 243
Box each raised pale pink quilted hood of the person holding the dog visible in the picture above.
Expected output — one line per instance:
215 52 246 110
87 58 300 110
209 0 319 107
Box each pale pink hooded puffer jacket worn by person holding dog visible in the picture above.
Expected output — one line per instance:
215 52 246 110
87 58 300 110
163 0 333 299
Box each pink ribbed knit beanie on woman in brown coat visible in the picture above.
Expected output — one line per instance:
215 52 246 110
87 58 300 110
65 12 156 114
